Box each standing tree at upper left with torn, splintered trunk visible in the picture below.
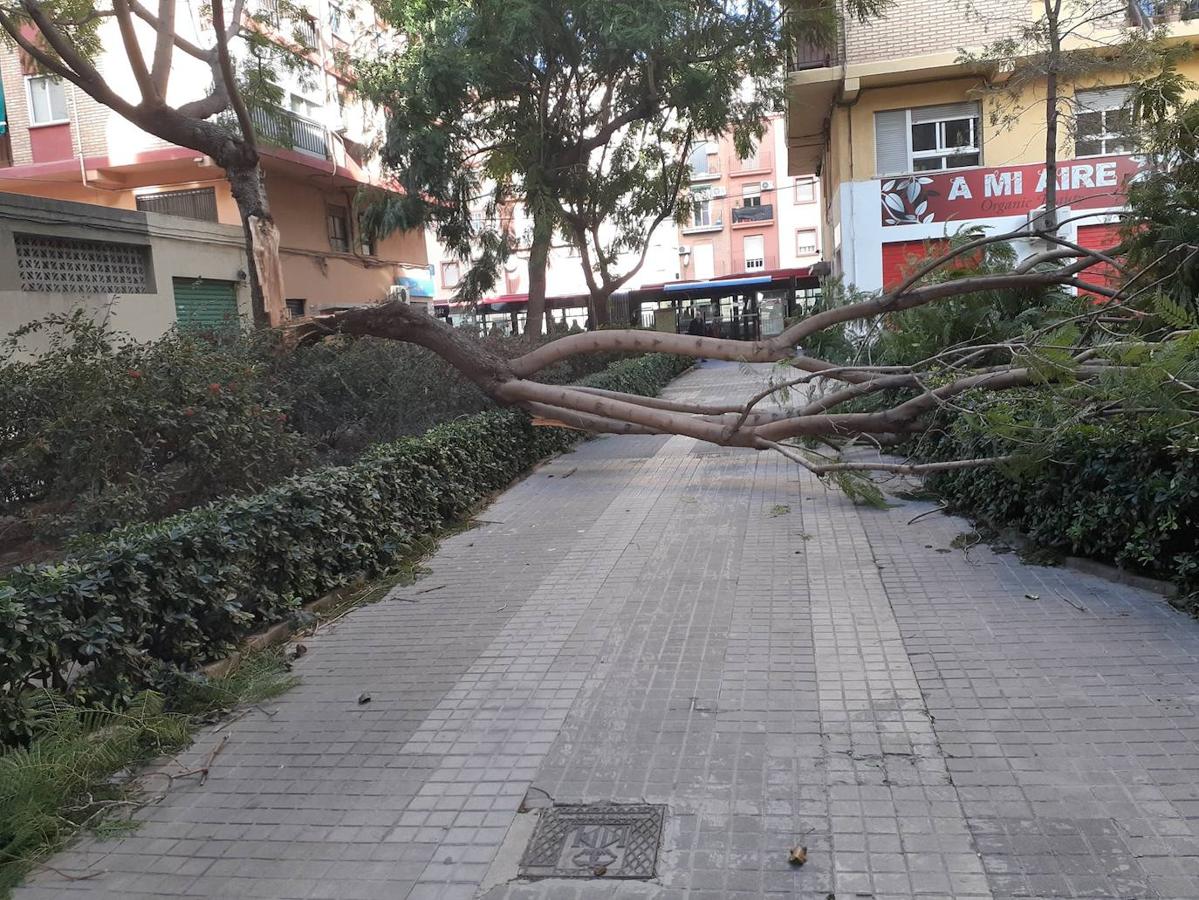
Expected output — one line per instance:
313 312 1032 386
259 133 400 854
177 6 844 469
0 0 321 322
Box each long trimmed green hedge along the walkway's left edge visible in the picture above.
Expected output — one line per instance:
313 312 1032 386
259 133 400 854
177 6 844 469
0 355 691 743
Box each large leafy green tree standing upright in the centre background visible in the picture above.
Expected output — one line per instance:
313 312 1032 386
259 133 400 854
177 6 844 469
362 0 882 332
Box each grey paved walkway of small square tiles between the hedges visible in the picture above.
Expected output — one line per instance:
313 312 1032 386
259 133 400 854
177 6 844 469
18 362 1199 900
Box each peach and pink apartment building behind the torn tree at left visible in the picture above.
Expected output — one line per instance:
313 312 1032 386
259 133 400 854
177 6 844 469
0 0 428 337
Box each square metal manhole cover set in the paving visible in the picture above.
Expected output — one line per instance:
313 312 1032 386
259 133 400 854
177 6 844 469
520 803 667 878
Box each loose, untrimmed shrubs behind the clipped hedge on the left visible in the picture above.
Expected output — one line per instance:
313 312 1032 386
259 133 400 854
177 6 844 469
0 313 626 566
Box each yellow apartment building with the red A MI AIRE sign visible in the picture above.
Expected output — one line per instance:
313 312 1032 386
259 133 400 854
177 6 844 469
787 0 1199 290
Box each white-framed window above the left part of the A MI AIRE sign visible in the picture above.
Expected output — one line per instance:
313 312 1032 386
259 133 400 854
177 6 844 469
874 103 982 175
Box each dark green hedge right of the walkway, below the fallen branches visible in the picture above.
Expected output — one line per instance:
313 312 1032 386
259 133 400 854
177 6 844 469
928 417 1199 612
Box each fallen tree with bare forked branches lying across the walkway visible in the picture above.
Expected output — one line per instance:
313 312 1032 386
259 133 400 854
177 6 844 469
299 215 1199 488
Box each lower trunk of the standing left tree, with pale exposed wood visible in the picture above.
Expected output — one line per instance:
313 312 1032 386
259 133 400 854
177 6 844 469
225 159 284 327
